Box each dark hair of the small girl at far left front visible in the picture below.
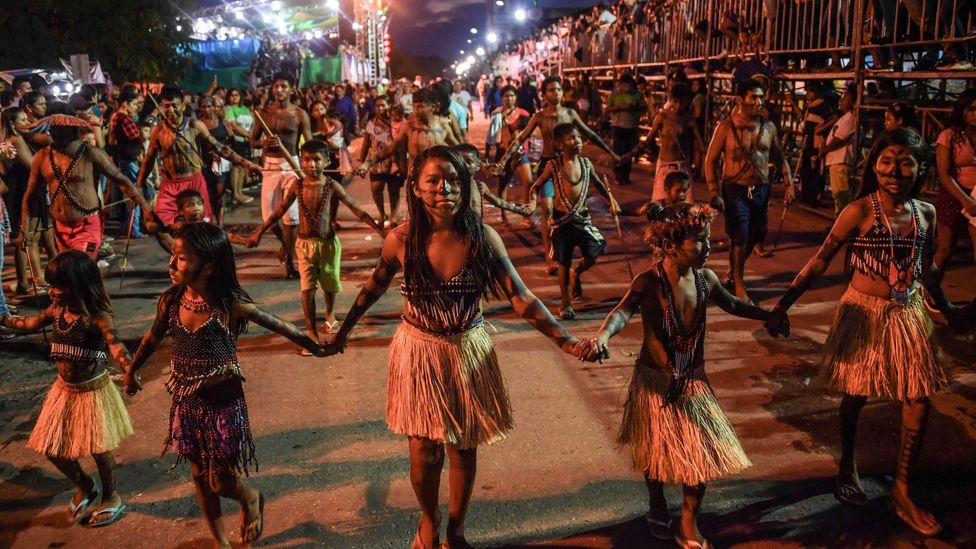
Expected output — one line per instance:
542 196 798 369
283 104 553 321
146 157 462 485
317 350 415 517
44 250 115 319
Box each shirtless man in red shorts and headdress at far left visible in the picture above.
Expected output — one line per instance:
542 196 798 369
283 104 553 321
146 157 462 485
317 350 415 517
23 115 156 259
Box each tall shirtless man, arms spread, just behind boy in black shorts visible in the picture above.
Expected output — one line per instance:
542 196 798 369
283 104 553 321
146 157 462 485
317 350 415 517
494 76 620 274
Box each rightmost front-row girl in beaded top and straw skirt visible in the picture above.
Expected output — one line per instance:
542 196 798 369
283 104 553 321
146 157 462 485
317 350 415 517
767 128 960 535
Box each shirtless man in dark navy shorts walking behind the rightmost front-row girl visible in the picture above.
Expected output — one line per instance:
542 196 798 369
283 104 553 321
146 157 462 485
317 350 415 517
705 80 793 301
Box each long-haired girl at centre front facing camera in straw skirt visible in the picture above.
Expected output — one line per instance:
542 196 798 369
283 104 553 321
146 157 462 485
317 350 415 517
326 146 577 549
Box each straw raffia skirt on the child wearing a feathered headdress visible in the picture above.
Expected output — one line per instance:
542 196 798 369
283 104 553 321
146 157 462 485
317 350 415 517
617 362 752 486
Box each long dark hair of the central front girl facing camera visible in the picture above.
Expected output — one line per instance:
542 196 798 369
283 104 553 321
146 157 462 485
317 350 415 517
403 145 501 307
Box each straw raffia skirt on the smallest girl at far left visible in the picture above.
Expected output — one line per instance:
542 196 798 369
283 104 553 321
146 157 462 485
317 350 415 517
27 372 132 459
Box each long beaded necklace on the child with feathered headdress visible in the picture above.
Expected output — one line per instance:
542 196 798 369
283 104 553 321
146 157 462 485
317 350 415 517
657 261 708 406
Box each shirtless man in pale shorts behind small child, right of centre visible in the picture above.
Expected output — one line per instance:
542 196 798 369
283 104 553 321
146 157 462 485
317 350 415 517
624 82 705 202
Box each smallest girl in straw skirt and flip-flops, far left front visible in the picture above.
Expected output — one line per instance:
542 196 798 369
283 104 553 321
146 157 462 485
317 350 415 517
0 250 132 527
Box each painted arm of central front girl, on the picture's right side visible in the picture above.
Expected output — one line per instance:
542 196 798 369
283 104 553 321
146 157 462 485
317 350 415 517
485 225 579 354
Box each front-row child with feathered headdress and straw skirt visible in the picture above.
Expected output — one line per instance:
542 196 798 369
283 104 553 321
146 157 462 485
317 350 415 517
582 203 768 548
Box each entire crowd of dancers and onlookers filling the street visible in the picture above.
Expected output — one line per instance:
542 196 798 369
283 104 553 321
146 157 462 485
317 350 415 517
0 20 976 548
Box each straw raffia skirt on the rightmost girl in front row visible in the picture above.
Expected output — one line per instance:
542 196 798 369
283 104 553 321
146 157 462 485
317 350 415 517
820 286 949 401
